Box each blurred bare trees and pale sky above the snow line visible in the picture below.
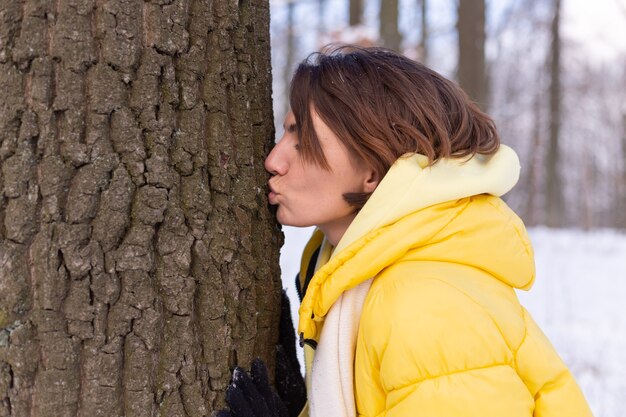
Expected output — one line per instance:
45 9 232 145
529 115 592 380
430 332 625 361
271 0 626 229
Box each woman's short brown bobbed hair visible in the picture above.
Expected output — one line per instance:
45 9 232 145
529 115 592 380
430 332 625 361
289 45 500 208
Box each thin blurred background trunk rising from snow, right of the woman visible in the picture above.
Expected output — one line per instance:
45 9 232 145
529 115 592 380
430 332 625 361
546 0 564 227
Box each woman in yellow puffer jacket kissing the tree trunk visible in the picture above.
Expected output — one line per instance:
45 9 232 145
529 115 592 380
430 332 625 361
218 46 591 417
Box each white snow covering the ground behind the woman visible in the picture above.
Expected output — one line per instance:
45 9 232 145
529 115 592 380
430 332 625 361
281 227 626 417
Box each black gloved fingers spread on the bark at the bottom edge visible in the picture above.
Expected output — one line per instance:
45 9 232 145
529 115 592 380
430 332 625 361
217 359 289 417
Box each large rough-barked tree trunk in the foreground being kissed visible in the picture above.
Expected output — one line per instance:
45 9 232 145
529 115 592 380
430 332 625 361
0 0 282 417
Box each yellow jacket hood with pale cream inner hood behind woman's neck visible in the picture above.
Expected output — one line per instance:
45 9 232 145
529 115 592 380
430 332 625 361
299 145 534 339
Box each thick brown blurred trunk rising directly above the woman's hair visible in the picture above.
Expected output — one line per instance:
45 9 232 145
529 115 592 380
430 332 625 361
457 0 488 109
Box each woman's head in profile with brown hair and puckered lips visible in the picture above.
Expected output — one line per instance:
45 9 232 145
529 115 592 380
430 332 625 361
265 46 499 240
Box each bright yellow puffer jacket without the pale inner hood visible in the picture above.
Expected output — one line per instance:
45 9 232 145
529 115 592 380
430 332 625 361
300 147 591 417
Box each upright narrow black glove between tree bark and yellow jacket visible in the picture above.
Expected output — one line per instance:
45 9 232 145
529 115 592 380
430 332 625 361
275 290 306 417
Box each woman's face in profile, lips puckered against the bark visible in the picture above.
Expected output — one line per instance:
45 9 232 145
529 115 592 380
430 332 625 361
265 111 378 245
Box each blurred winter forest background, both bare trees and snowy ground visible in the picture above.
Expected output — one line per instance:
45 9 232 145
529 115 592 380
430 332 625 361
271 0 626 417
